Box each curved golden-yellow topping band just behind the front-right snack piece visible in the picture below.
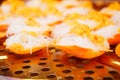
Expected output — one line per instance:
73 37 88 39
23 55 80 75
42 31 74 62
64 10 113 30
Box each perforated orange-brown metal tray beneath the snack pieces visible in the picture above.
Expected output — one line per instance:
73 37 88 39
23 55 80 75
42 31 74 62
0 44 120 80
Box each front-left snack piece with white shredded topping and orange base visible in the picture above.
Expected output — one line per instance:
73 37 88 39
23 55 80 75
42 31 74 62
5 34 52 54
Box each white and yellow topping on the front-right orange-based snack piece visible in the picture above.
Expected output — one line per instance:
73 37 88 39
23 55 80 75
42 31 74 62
53 22 109 51
